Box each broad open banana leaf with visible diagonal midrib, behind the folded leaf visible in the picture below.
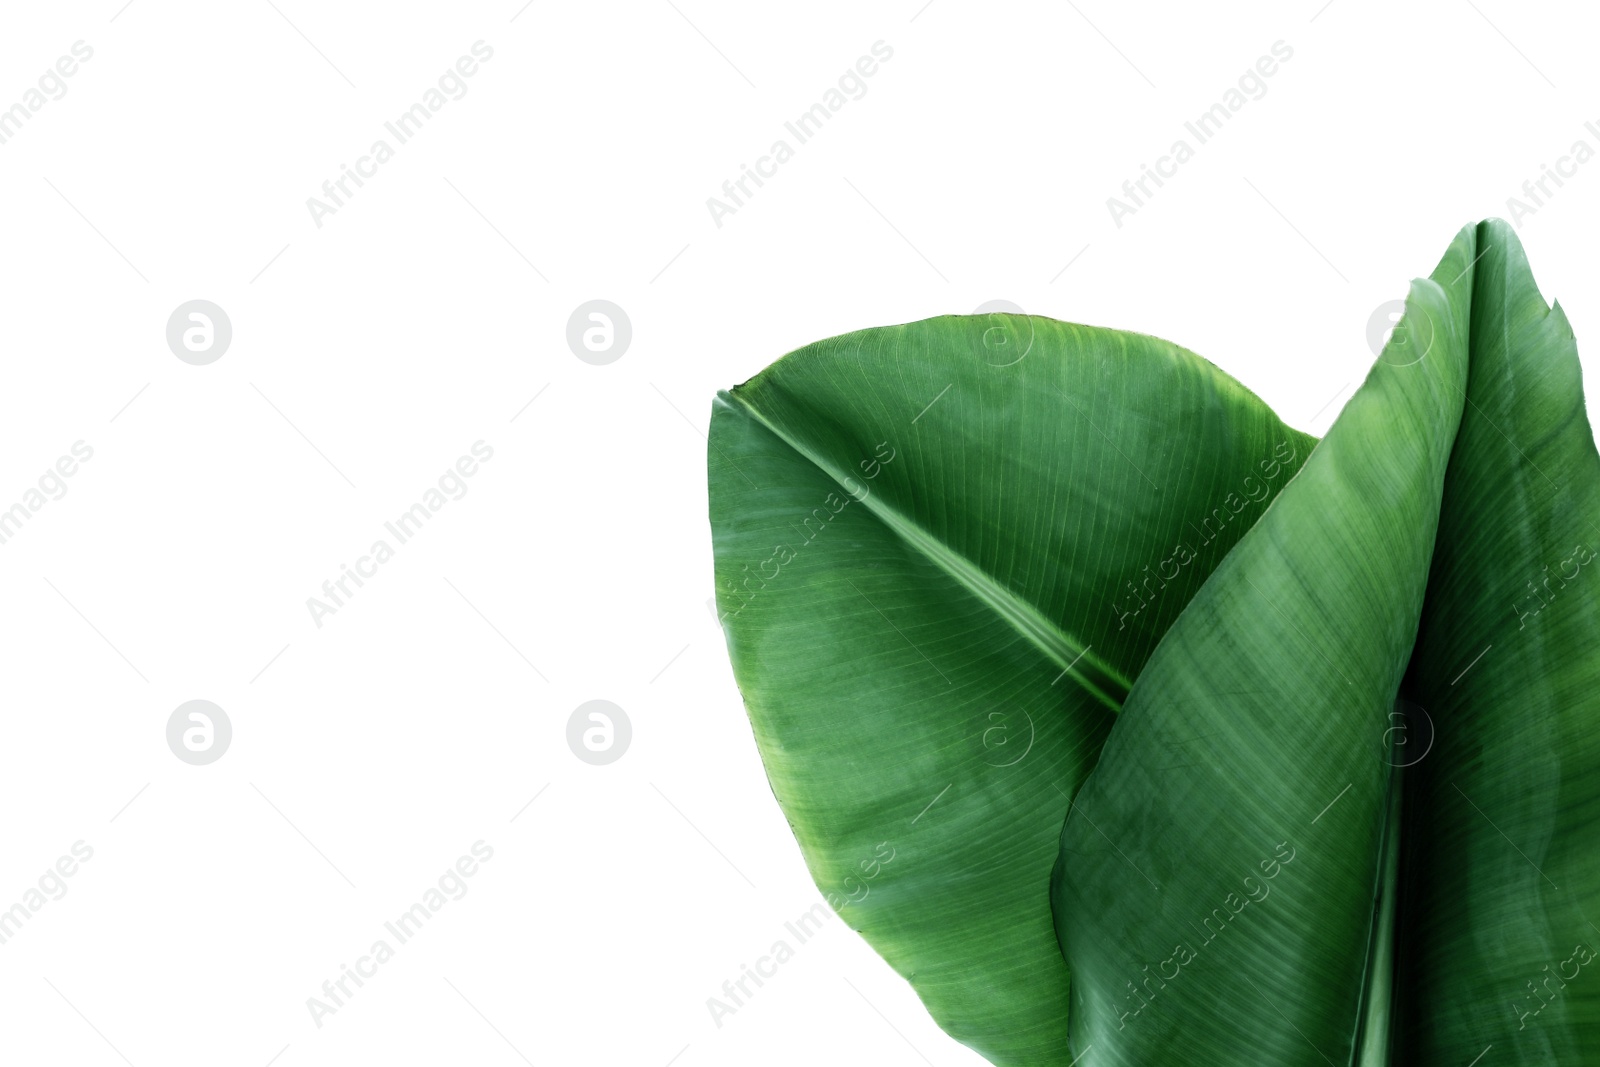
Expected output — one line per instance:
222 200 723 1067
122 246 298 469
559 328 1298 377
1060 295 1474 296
709 315 1312 1065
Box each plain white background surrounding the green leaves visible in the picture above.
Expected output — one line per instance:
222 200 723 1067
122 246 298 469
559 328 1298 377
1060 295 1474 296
0 0 1600 1067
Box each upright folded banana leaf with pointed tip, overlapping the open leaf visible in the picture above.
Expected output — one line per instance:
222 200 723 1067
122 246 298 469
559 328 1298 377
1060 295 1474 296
1051 222 1600 1067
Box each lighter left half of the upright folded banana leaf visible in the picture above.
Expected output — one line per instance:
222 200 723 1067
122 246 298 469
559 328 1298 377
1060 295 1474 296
1051 220 1475 1067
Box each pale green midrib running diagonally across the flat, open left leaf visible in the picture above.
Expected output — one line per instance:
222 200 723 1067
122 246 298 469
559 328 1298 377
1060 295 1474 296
717 390 1133 712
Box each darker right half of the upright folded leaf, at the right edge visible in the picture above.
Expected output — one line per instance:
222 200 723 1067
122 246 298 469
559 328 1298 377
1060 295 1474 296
1395 221 1600 1065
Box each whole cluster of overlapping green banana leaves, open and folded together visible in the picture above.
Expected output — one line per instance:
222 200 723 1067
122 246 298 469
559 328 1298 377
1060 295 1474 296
709 222 1600 1067
